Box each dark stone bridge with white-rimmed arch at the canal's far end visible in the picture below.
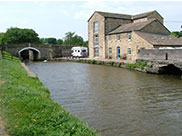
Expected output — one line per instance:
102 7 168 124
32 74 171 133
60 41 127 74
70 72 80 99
3 43 72 61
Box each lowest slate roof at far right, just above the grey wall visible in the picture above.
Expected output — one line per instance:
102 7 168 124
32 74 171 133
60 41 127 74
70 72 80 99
135 31 182 46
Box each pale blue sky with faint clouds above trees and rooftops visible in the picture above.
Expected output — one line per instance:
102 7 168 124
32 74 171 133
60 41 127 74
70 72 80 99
0 0 182 40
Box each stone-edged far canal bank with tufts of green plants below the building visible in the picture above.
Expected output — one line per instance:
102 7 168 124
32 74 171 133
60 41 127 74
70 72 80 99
53 57 182 78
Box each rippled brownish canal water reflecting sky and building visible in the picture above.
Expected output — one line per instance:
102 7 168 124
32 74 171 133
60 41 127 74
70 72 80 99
28 62 182 136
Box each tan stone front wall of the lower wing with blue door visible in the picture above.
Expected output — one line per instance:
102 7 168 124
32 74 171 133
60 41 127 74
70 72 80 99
106 32 153 61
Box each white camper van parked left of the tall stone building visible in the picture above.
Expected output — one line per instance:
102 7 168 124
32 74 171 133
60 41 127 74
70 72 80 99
71 47 88 58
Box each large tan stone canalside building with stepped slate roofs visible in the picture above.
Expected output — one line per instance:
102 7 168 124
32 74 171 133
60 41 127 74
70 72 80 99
88 11 182 60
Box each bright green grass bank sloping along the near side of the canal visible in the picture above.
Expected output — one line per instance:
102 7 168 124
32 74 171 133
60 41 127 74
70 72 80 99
0 54 99 136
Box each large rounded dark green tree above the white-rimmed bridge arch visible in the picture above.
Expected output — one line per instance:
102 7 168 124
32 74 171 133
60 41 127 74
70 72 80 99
3 27 39 44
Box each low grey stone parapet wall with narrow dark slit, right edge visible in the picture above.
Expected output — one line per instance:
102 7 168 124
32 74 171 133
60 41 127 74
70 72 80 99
137 49 182 61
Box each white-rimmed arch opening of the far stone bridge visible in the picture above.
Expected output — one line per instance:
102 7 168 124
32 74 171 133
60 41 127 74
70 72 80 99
18 47 41 61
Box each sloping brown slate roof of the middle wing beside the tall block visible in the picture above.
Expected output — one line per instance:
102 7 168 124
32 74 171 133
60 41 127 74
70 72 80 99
108 19 156 34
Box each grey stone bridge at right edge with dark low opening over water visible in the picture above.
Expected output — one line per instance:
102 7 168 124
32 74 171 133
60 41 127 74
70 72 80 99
137 48 182 76
